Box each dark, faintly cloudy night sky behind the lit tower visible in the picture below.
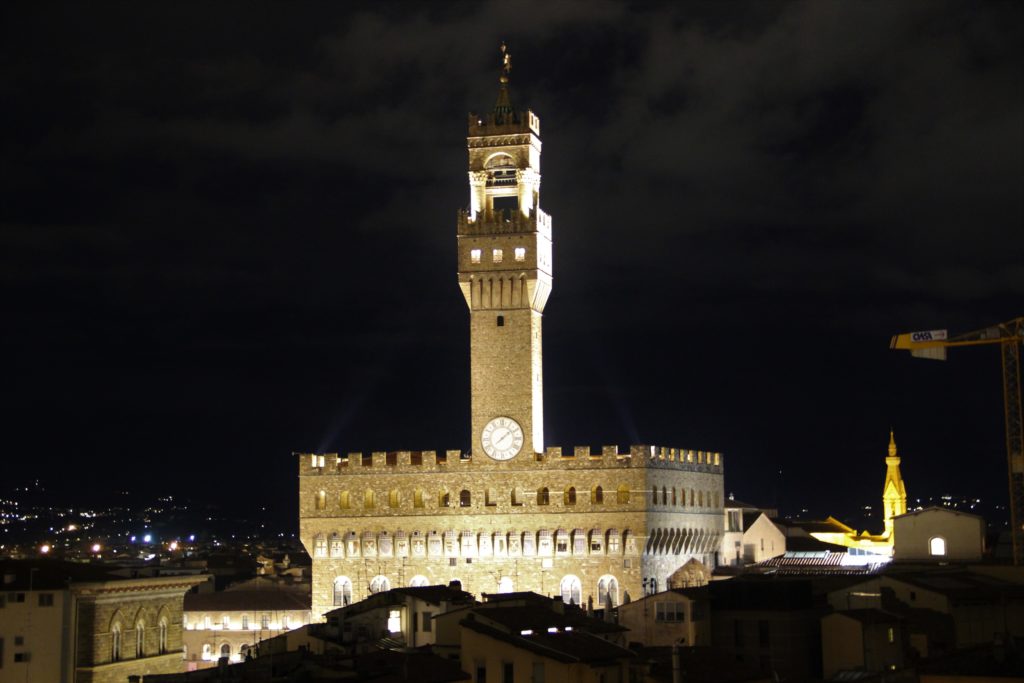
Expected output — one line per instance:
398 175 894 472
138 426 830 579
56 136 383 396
0 0 1024 530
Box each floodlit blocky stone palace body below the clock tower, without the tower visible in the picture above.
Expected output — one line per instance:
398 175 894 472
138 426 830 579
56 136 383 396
299 445 723 618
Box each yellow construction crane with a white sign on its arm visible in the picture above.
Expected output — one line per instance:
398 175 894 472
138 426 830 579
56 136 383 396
889 317 1024 565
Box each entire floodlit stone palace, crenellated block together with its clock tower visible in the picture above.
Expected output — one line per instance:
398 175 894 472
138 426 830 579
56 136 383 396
299 46 724 620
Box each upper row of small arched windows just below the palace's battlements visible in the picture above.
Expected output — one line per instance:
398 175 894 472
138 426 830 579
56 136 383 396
313 484 721 510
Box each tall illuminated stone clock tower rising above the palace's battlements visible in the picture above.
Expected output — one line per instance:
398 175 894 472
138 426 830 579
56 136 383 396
458 45 551 461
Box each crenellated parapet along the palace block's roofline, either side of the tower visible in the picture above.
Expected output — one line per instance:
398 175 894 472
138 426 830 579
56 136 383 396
298 444 725 475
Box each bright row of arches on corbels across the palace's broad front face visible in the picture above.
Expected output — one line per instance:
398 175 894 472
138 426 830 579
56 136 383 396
313 528 637 558
